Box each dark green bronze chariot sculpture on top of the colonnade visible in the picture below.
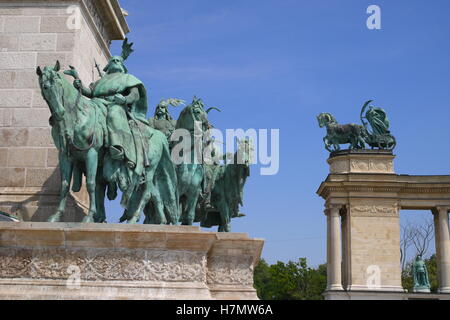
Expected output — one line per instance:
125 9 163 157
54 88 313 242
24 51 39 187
317 100 397 152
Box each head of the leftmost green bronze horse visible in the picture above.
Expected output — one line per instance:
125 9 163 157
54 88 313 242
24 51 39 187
36 61 65 121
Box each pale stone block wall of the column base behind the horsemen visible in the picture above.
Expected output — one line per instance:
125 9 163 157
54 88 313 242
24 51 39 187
0 0 129 221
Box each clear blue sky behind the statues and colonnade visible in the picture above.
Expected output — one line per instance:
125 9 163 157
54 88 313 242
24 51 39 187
108 0 450 265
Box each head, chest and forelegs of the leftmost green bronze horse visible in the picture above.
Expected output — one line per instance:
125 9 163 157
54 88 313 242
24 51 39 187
36 62 107 222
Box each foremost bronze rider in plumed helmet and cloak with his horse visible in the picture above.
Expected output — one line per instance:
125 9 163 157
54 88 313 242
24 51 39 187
37 41 179 224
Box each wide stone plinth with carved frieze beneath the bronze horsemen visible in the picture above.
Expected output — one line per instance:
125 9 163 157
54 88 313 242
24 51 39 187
0 222 264 300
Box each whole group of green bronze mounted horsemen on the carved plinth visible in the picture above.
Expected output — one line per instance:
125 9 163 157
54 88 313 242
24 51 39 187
36 39 249 232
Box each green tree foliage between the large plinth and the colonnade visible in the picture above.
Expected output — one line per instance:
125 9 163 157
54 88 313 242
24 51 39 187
254 258 327 300
